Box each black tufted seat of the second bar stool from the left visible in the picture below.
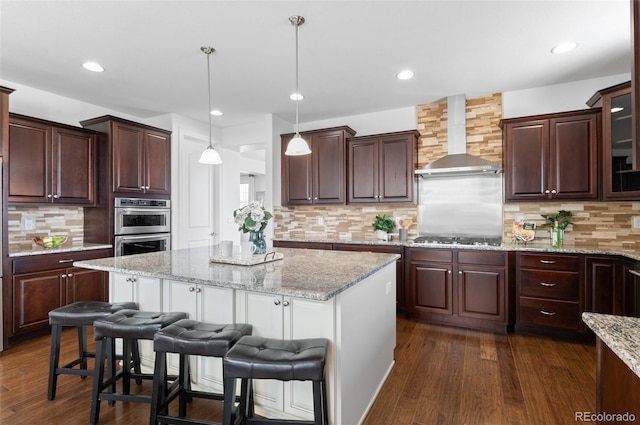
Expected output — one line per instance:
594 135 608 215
93 309 187 341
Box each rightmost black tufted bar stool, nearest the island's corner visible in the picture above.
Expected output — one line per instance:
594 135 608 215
222 336 329 425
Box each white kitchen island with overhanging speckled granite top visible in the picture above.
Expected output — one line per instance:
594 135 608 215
74 248 398 425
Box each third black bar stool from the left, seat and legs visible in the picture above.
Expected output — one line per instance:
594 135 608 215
149 319 253 425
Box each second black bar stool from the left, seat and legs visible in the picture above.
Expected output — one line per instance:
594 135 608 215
89 310 187 425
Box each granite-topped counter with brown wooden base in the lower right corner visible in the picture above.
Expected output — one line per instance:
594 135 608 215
582 312 640 423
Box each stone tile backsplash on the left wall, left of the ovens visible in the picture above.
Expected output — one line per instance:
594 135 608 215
7 205 84 253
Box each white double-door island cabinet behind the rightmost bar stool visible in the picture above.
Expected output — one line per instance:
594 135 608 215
236 291 334 419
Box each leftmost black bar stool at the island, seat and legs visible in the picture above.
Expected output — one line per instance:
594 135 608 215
47 301 140 400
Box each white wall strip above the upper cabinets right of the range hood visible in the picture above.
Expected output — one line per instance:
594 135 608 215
502 73 631 118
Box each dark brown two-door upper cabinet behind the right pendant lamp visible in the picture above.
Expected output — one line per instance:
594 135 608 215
280 126 355 206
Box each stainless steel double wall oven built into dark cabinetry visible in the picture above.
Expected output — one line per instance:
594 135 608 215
114 198 171 256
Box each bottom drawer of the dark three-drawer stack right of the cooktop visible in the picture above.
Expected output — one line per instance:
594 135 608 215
519 297 579 330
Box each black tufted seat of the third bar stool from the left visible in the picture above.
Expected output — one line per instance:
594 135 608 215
153 319 253 357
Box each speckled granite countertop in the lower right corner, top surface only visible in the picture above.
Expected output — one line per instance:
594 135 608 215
582 312 640 377
